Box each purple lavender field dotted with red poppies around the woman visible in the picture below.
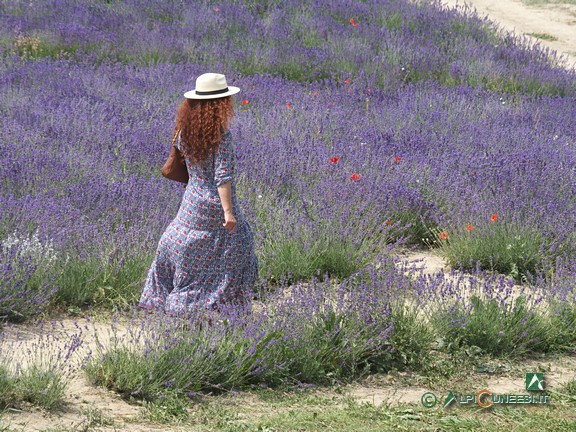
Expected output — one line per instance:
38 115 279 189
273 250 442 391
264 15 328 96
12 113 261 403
0 0 576 426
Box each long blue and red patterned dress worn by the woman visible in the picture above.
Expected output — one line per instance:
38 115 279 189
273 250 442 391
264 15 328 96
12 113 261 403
140 131 258 315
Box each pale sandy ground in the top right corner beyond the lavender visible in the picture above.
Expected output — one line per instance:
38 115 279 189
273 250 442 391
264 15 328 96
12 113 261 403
442 0 576 68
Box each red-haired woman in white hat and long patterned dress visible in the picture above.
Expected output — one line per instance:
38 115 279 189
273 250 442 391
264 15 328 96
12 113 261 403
140 73 258 316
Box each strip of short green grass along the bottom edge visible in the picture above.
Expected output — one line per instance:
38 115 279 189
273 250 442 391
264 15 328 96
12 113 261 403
111 388 576 432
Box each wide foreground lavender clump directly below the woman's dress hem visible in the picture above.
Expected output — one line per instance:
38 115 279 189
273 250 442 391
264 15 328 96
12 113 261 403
87 270 400 400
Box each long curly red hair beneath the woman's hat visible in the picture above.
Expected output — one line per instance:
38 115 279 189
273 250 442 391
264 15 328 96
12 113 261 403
174 96 234 164
